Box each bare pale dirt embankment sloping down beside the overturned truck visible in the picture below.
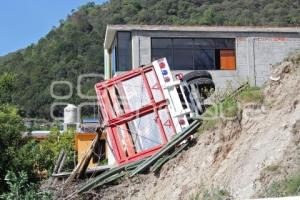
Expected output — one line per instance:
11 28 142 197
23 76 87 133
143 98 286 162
74 53 300 200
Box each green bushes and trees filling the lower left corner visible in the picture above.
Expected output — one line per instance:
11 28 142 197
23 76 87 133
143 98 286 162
0 73 74 195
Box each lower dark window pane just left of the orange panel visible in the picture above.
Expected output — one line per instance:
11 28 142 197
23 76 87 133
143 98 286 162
195 49 215 70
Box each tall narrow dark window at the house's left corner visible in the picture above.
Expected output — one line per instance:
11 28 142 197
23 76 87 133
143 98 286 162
117 32 132 71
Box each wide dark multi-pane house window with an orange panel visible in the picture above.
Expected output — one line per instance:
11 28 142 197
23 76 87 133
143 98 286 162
151 38 236 70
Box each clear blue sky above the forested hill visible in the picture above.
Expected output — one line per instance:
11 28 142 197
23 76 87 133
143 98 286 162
0 0 105 56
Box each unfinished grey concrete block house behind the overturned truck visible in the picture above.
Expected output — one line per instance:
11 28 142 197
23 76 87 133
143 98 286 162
104 25 300 89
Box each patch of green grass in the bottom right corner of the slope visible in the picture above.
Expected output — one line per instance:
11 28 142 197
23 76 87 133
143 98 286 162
262 172 300 197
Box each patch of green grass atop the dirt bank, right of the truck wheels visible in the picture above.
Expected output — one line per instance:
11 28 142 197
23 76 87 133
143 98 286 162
237 87 264 103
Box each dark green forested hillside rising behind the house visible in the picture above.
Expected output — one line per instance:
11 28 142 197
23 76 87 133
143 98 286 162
0 0 300 118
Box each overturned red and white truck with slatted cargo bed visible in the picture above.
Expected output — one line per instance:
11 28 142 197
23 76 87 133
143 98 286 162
95 58 215 164
